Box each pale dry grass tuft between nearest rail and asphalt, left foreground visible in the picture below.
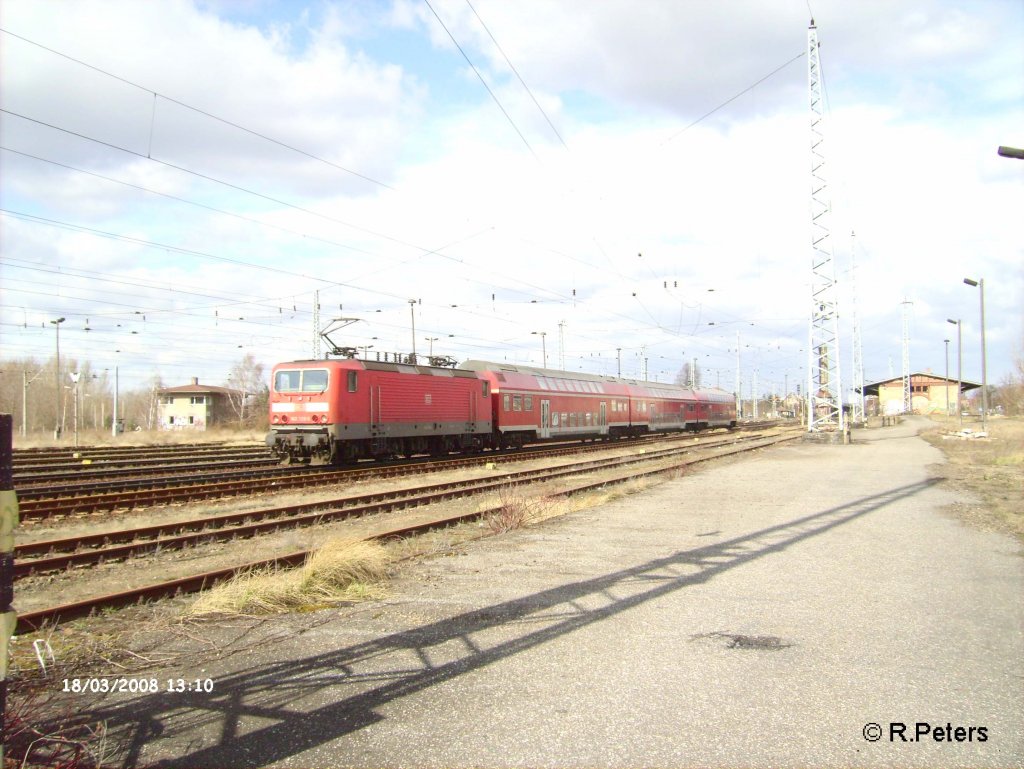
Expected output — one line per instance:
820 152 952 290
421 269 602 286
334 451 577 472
188 540 390 616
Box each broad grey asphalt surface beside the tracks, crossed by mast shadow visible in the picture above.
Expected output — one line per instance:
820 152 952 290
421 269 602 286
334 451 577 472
64 421 1024 767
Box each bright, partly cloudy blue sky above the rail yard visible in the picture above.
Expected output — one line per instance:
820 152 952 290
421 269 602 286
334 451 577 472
0 0 1024 395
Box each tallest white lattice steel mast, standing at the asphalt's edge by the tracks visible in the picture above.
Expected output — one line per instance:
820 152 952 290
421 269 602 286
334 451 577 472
807 18 845 432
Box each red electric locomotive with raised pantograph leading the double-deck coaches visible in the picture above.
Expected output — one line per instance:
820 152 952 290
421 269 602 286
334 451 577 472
266 358 493 462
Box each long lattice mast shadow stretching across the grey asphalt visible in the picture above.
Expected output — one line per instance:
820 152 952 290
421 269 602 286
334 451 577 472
87 478 939 769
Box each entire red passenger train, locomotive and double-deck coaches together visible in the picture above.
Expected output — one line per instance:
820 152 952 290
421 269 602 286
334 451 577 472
266 358 736 464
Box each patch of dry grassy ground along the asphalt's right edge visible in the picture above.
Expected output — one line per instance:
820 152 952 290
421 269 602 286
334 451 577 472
925 418 1024 541
